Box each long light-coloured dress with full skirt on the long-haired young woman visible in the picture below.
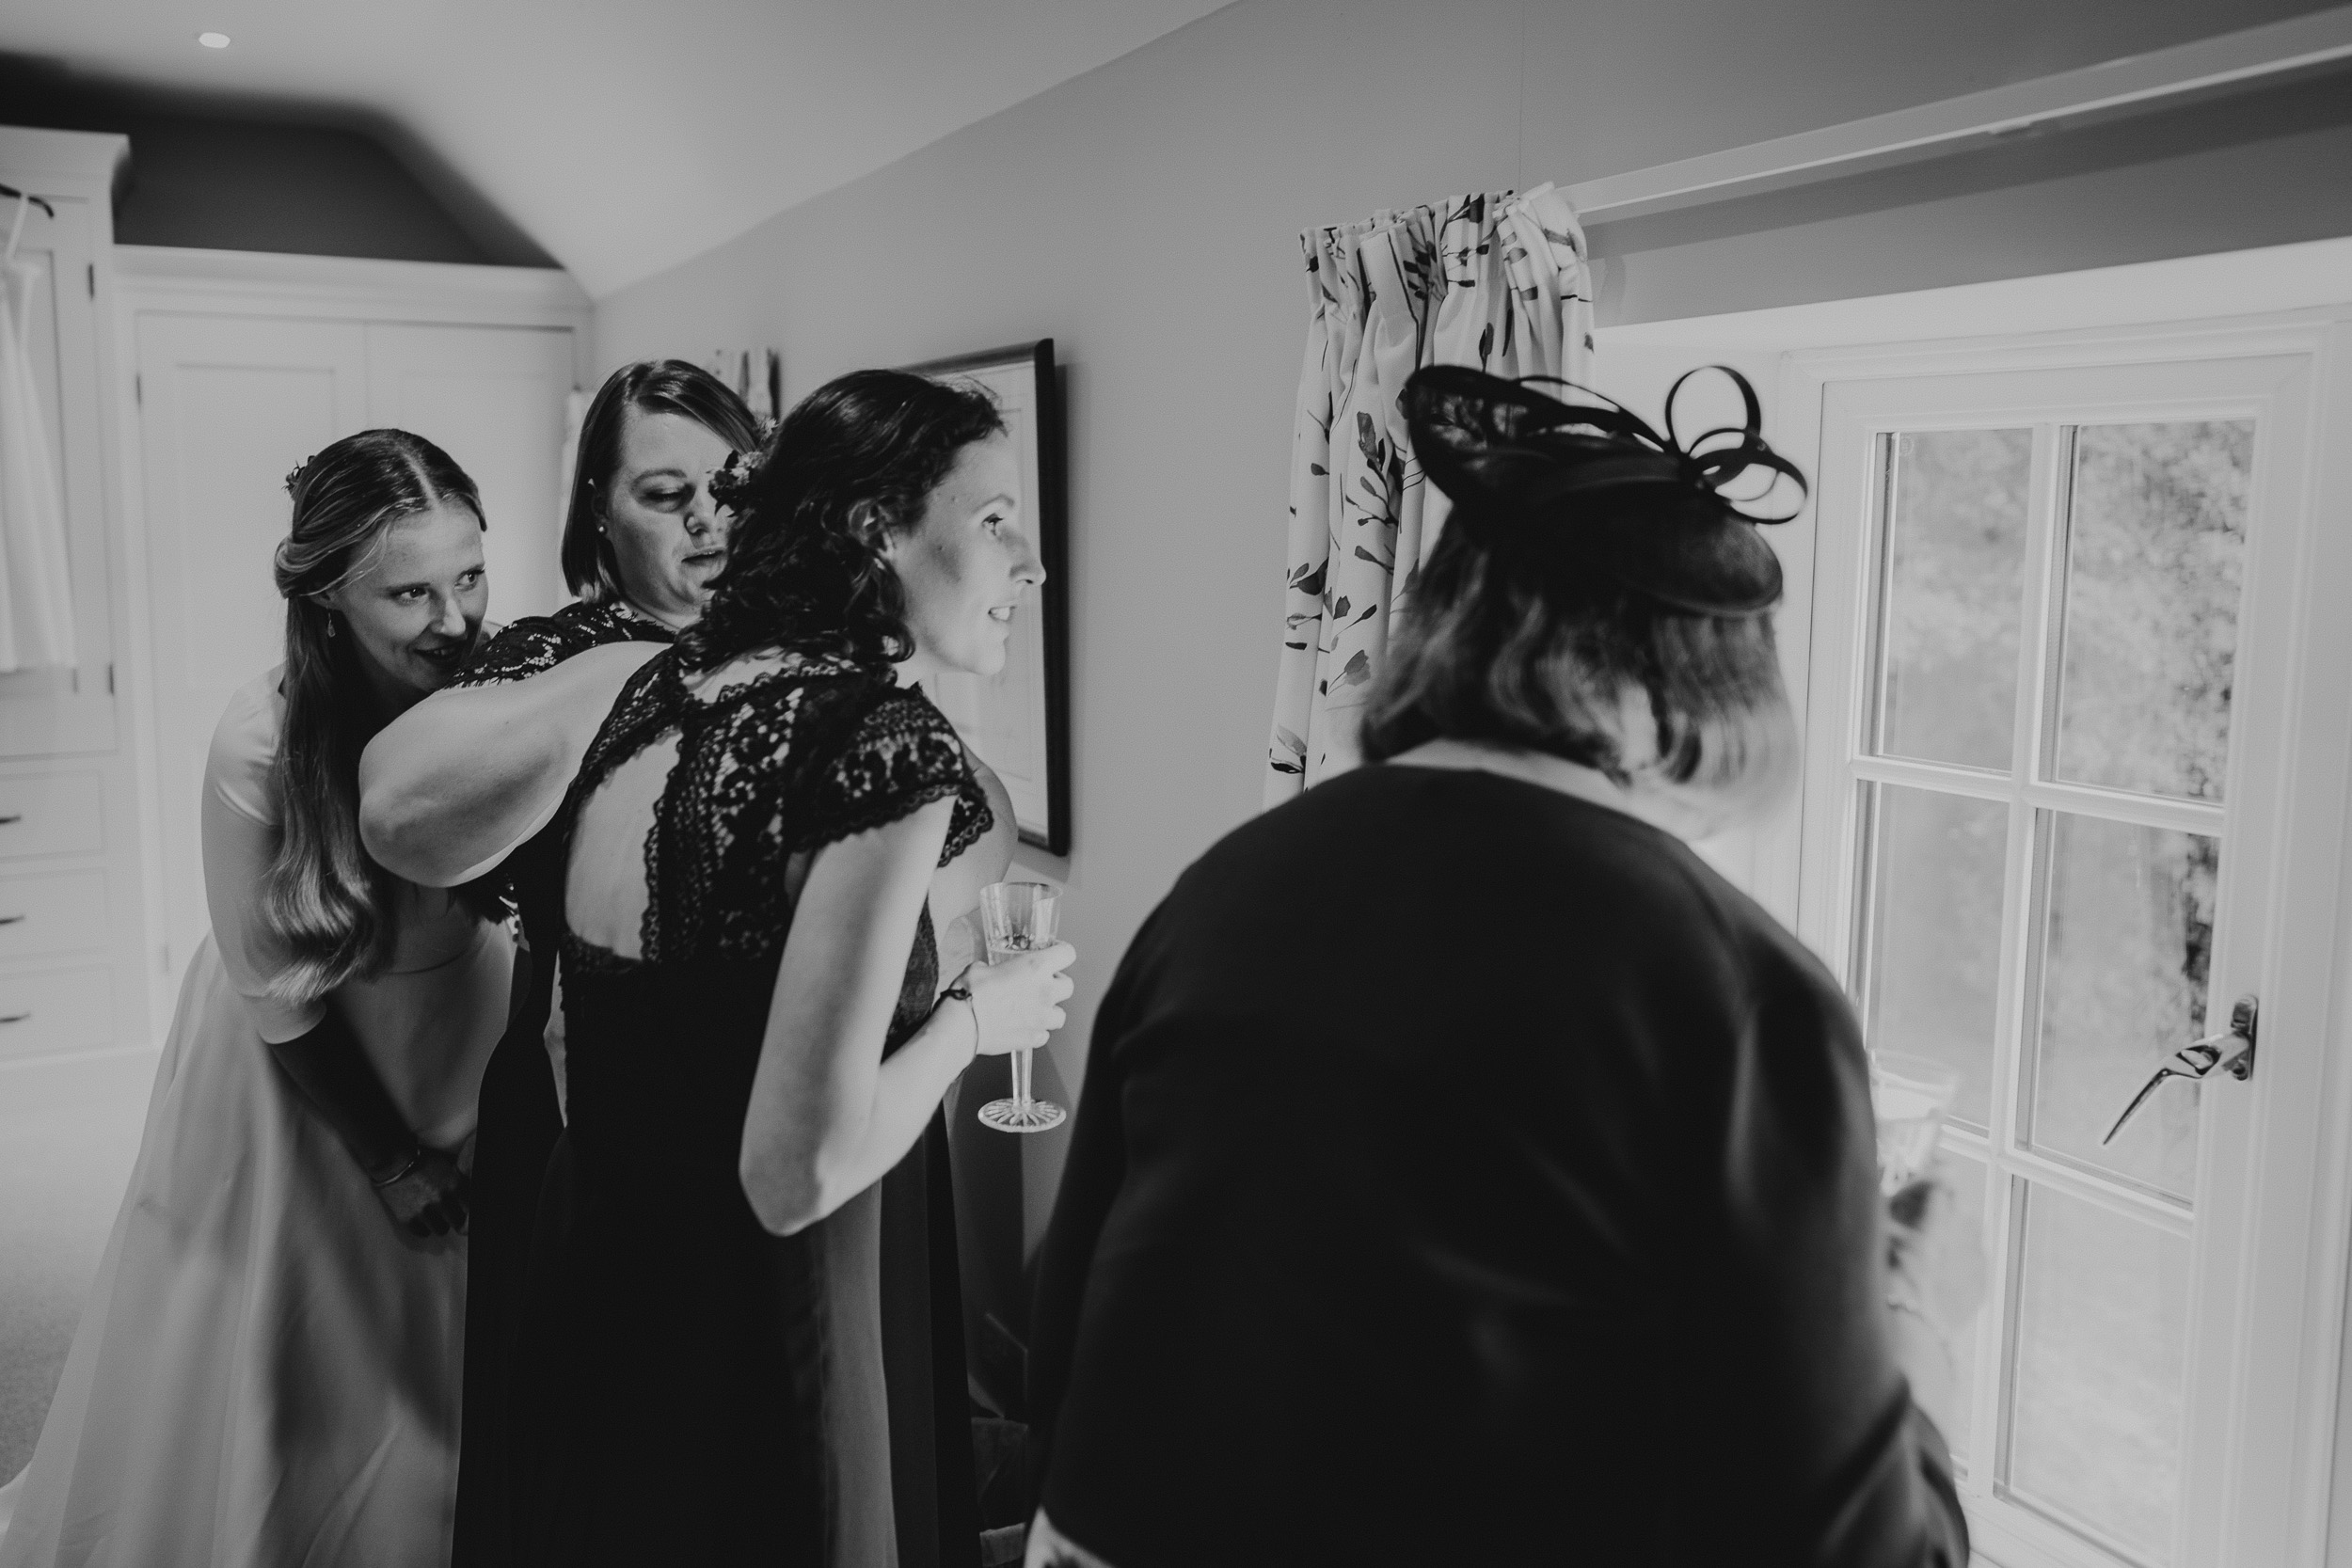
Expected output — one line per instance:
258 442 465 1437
0 670 516 1568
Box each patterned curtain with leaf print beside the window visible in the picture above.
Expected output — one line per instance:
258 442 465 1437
1265 185 1593 806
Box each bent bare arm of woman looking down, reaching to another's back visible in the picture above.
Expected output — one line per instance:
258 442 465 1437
360 641 663 886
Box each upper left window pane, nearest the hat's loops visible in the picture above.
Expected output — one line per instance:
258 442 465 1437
1877 430 2035 768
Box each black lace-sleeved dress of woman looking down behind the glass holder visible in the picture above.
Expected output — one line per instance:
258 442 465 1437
450 604 677 1568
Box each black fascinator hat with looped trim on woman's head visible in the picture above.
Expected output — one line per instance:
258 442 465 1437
1402 364 1804 618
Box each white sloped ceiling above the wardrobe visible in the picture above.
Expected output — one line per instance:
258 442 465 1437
0 0 1228 296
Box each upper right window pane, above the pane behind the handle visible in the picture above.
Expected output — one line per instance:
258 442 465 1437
2058 420 2253 800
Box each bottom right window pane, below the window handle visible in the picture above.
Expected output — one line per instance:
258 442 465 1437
2009 1182 2190 1561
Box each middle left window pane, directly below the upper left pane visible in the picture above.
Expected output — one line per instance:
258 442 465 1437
1863 785 2009 1131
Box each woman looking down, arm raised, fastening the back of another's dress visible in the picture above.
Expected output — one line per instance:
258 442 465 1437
360 359 760 1568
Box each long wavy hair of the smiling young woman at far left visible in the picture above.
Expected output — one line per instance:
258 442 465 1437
259 430 487 1002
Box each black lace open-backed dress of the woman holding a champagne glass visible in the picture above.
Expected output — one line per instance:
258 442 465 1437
527 656 991 1568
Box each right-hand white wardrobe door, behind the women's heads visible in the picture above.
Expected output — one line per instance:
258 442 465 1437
367 325 572 621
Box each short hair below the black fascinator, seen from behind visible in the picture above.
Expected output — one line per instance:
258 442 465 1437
1358 527 1788 785
